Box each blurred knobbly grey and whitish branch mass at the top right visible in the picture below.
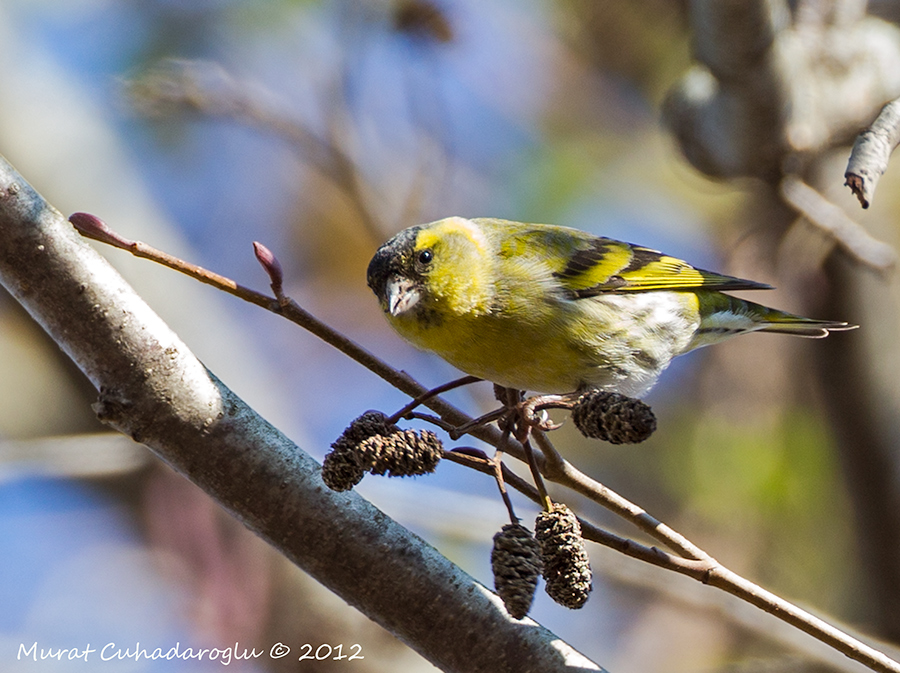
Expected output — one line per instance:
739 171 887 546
665 0 900 182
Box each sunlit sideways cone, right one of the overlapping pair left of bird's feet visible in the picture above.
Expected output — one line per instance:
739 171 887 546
356 430 444 477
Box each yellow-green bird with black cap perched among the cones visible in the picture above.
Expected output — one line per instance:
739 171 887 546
367 217 857 397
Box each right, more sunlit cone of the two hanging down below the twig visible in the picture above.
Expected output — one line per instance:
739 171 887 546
534 503 593 610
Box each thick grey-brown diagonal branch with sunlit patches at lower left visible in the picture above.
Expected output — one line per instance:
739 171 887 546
0 160 599 671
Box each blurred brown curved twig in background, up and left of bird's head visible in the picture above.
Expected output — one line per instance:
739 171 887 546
128 61 384 242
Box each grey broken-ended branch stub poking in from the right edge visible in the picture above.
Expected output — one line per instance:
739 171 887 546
844 99 900 208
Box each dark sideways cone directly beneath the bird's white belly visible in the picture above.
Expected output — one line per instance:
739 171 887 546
572 390 656 444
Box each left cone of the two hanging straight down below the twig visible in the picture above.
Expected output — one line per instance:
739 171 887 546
491 523 541 619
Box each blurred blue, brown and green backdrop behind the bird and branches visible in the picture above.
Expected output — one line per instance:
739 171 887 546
0 0 900 673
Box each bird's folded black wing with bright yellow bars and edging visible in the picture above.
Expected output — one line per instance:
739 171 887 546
553 238 771 299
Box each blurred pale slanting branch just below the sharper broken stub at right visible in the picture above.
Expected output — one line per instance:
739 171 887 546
781 175 897 271
